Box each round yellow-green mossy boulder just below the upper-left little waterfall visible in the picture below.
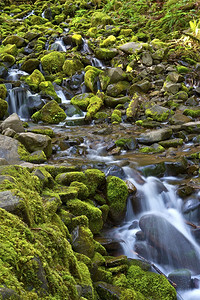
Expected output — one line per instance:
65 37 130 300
41 51 65 74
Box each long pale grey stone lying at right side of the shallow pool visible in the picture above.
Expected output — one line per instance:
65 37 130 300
138 128 172 144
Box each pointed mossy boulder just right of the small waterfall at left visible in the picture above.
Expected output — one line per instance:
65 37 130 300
31 100 66 124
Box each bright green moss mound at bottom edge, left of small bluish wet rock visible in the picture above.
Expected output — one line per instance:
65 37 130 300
127 266 176 300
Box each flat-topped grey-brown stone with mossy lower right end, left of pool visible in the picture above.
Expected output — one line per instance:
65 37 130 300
17 132 52 157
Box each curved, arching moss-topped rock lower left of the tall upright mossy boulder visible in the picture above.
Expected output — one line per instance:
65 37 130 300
66 199 103 233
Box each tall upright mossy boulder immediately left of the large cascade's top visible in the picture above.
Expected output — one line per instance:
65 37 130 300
107 176 128 224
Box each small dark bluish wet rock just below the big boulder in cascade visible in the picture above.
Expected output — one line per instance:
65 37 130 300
168 269 191 290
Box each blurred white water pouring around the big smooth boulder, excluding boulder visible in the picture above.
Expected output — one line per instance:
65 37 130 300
108 167 200 300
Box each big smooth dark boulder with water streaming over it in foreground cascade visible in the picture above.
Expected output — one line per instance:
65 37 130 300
139 214 200 273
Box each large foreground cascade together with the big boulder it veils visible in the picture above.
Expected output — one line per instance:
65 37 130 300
108 167 200 300
